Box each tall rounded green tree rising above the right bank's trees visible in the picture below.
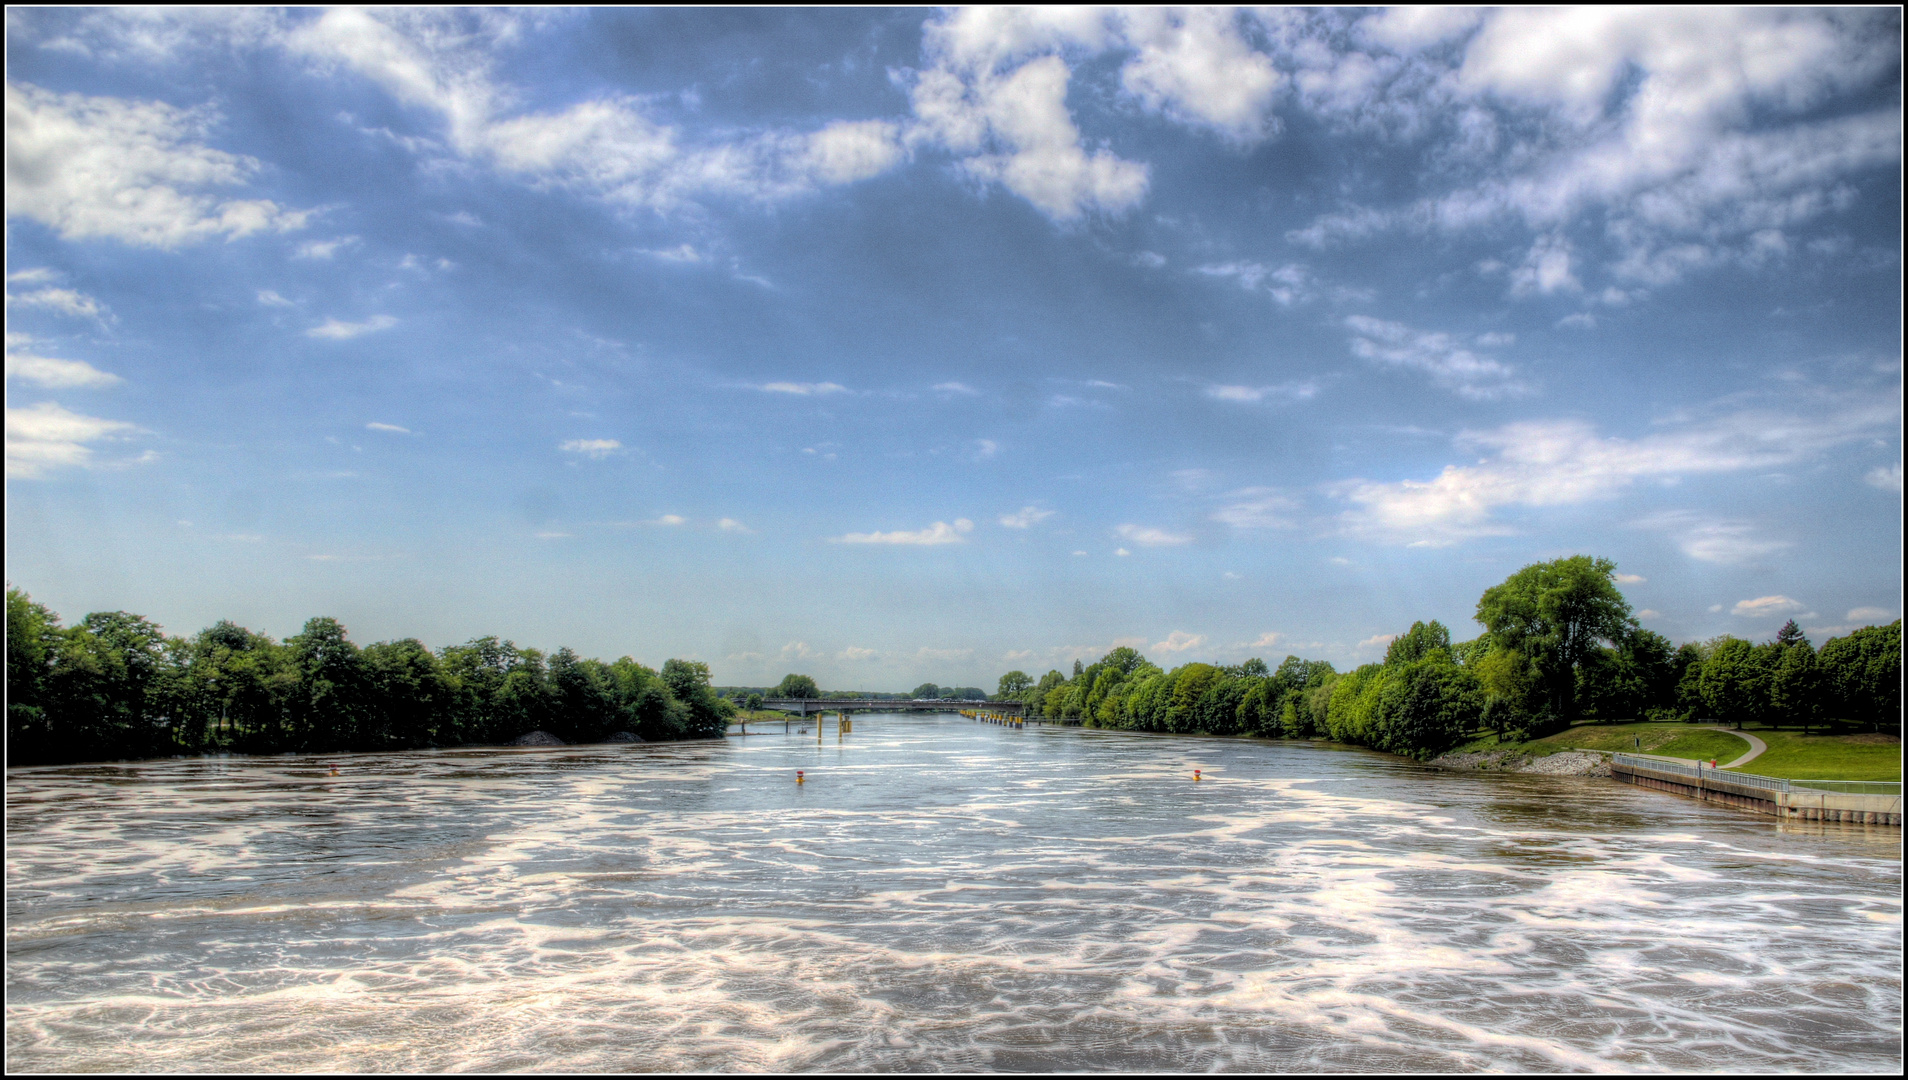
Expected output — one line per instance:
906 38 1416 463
1477 555 1637 723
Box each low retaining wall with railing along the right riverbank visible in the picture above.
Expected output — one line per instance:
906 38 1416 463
1610 754 1902 826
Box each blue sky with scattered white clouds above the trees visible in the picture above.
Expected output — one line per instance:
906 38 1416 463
6 8 1902 689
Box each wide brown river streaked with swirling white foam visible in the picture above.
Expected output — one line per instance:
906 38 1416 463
6 716 1902 1072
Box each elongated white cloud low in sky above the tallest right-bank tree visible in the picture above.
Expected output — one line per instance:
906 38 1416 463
1336 397 1898 545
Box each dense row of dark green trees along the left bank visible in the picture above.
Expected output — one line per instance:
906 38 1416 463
6 586 735 765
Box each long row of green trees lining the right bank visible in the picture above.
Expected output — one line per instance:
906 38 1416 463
996 555 1902 759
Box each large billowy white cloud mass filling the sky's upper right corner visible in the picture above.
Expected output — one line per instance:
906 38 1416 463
1294 8 1900 286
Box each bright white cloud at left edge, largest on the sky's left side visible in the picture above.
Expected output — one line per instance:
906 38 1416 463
6 82 309 248
